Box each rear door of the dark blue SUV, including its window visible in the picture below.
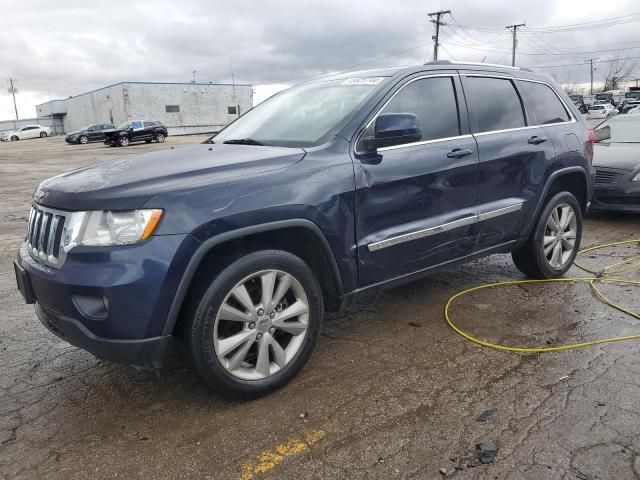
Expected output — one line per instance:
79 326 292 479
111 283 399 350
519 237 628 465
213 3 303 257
462 73 555 251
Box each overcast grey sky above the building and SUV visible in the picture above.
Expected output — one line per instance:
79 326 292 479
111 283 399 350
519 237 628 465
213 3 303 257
0 0 640 120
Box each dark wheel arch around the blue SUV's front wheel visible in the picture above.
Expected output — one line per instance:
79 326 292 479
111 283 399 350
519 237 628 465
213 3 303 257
162 219 344 335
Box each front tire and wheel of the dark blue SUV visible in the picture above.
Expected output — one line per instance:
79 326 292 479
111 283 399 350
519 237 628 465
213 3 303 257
178 250 324 400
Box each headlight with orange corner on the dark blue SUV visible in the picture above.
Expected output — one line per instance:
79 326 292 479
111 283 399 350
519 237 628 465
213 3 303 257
62 209 163 252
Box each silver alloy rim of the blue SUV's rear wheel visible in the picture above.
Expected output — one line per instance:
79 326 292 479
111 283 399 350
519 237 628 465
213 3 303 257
543 203 578 269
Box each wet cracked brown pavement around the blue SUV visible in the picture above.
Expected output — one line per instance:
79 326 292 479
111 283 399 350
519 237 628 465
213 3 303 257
0 137 640 480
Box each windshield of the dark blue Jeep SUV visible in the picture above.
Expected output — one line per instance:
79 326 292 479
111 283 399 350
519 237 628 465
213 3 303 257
208 77 384 147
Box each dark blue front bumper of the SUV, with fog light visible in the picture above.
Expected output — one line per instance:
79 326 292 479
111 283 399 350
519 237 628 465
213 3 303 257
16 235 199 367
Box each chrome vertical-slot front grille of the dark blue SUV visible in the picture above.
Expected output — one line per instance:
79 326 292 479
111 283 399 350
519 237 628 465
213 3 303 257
26 205 67 268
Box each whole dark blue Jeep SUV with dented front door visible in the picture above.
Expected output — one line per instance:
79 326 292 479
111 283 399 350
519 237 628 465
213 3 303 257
15 61 594 398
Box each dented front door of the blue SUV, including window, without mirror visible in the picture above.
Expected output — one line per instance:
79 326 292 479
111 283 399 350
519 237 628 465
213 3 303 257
354 73 478 286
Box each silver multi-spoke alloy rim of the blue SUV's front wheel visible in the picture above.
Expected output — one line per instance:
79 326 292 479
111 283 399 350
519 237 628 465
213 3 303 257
213 270 309 380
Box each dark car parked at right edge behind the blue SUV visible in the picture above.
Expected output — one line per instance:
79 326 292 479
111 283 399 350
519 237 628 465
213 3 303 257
591 115 640 213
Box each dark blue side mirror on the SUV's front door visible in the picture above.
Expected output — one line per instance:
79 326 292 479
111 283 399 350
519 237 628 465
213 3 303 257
364 113 422 151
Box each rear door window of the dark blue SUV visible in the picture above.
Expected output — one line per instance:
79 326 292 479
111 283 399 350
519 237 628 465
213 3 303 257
466 77 525 132
